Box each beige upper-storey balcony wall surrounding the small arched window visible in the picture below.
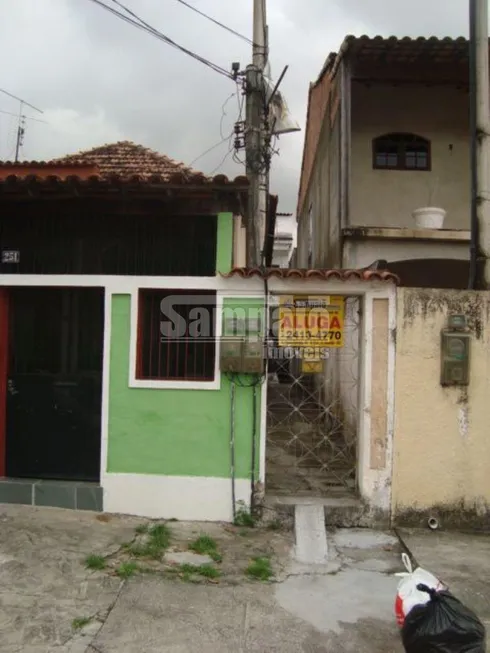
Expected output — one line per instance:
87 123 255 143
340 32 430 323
349 82 470 229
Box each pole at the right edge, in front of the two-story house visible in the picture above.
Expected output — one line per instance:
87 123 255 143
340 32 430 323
470 0 490 290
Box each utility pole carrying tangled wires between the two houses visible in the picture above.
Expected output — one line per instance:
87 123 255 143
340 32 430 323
245 0 269 267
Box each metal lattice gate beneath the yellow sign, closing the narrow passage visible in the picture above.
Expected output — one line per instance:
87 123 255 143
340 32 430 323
266 297 361 496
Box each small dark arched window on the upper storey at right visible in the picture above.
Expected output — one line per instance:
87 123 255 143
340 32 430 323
373 134 430 170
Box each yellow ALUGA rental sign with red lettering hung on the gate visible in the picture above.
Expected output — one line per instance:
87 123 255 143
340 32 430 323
279 295 345 347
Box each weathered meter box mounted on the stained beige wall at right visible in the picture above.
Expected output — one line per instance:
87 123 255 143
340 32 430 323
441 315 471 386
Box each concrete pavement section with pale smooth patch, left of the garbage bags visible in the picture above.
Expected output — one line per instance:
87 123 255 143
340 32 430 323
89 531 403 653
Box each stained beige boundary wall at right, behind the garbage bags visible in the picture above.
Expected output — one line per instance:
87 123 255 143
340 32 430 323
392 288 490 525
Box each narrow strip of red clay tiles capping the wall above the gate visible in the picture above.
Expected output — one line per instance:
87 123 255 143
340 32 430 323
222 268 400 284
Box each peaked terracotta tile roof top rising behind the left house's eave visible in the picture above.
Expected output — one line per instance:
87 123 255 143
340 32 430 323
50 141 209 181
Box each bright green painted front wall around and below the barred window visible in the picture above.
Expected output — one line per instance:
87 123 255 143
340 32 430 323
107 295 260 478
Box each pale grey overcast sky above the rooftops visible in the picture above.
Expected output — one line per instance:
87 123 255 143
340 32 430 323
0 0 468 211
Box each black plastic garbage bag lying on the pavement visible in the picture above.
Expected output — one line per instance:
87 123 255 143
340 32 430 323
401 585 486 653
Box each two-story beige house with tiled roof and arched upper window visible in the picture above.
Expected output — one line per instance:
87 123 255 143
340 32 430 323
296 36 470 288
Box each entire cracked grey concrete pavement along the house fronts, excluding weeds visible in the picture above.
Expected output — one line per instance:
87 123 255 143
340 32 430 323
0 505 490 653
